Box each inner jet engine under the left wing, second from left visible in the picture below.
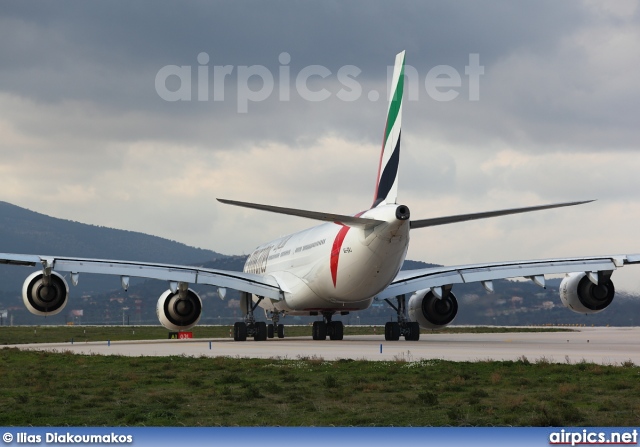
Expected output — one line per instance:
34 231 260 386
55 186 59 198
156 289 202 331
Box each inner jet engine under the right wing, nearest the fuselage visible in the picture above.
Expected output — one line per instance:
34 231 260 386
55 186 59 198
407 290 458 329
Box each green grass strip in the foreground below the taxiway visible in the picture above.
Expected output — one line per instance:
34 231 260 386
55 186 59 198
0 348 640 426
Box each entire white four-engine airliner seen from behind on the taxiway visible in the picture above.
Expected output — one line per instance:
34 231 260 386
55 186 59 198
0 51 640 341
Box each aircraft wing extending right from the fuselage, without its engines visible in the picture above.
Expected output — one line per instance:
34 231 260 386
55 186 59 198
376 254 640 299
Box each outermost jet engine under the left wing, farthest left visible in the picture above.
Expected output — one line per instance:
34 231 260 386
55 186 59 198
22 271 69 316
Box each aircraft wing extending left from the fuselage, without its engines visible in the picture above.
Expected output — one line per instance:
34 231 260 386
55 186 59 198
0 253 281 299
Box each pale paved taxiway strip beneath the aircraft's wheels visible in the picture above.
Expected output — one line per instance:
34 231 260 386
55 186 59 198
8 327 640 365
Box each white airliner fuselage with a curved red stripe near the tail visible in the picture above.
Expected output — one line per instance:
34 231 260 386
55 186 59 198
244 205 409 315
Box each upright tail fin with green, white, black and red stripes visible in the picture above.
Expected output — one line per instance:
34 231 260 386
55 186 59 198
372 51 404 208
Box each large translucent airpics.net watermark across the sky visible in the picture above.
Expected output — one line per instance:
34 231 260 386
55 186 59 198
155 52 484 113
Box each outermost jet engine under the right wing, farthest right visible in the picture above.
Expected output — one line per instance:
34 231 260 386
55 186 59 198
560 273 616 314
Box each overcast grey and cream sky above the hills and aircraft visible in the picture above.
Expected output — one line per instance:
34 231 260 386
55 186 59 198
0 0 640 290
